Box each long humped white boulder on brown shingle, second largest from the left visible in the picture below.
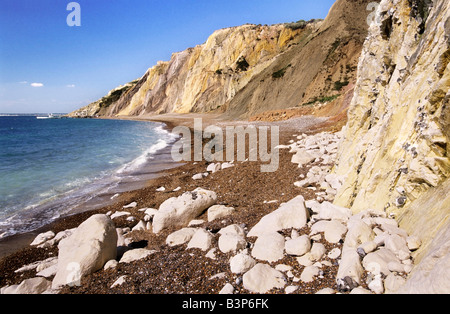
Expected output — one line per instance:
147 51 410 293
153 188 217 233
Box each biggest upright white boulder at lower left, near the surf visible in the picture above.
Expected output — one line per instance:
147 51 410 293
52 215 117 289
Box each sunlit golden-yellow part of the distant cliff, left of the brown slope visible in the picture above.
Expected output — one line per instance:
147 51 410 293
72 21 312 116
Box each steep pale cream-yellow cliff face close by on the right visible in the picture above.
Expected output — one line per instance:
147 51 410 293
334 0 450 292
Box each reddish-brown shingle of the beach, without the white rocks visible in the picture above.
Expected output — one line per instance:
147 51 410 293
0 115 348 294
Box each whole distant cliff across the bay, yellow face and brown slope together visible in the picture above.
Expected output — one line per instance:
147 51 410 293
71 0 371 118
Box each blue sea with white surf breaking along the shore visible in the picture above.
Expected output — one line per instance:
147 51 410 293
0 116 176 238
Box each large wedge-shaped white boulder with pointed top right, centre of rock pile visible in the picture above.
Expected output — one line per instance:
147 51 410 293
248 195 309 237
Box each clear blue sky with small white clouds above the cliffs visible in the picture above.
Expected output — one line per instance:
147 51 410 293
0 0 335 113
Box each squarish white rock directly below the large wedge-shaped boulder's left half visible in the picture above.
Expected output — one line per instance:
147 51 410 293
252 232 284 262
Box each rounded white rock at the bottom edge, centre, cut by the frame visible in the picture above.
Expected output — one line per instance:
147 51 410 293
242 263 286 293
